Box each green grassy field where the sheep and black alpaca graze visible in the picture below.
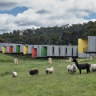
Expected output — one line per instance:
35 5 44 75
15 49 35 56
0 54 96 96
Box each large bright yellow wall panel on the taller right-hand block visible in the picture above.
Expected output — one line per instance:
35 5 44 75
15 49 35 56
78 39 88 53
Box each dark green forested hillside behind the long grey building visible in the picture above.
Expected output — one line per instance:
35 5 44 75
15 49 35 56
0 21 96 45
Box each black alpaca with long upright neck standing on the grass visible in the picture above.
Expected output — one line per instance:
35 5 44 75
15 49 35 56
73 58 90 74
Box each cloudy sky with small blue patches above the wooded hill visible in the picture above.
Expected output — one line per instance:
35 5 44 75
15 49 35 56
0 0 96 34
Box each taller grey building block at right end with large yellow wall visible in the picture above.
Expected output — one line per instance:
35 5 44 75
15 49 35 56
78 36 96 58
